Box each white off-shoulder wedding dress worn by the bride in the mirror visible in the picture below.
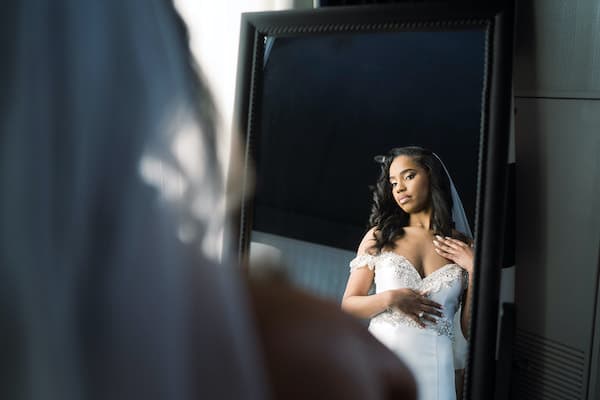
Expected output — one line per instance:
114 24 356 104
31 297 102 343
350 251 468 400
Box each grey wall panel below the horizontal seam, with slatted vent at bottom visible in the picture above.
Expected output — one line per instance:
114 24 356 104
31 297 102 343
513 99 600 399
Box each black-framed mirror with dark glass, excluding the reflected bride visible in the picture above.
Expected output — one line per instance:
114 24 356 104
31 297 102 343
234 4 511 399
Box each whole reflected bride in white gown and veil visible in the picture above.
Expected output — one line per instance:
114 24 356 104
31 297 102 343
342 147 473 400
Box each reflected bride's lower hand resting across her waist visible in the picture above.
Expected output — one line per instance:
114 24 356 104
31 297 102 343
389 288 443 328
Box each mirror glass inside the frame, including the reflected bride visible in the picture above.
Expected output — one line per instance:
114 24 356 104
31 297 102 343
250 29 485 399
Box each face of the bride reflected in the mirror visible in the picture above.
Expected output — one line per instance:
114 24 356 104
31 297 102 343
389 156 430 214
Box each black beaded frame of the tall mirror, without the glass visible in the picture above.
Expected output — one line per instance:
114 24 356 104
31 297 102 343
225 0 514 399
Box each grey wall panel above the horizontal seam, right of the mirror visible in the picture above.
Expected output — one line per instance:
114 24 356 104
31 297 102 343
514 0 600 99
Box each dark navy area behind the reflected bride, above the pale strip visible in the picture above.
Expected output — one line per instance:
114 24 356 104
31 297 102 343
253 30 485 250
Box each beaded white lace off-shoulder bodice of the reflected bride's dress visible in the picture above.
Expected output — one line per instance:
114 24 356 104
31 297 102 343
350 251 469 339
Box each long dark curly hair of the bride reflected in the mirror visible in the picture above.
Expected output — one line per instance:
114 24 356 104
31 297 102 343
369 146 460 253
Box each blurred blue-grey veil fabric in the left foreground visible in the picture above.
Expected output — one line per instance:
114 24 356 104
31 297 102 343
0 0 266 400
